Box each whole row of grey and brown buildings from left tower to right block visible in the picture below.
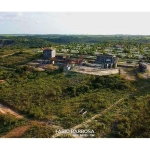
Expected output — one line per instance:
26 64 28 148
42 48 118 69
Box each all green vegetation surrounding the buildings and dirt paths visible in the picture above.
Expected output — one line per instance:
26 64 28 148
0 35 150 138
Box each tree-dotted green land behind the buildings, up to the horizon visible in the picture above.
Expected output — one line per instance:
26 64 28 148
0 35 150 61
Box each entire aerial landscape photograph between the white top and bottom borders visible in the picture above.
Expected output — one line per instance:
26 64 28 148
0 12 150 138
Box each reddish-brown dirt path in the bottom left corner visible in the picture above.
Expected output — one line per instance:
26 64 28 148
1 125 30 138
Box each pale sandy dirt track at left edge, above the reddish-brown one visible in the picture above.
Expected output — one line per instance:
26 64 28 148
0 104 23 119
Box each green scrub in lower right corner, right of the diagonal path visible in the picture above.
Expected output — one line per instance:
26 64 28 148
81 81 150 138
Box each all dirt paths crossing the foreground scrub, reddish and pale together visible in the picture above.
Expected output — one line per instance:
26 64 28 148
0 85 149 138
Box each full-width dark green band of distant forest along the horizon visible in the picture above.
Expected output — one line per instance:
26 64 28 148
0 35 150 48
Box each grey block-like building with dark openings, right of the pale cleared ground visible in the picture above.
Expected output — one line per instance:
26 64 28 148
96 54 118 68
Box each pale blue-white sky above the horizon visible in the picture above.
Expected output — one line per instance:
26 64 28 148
0 12 150 35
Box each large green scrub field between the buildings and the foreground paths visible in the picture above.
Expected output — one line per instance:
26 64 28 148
0 68 132 128
